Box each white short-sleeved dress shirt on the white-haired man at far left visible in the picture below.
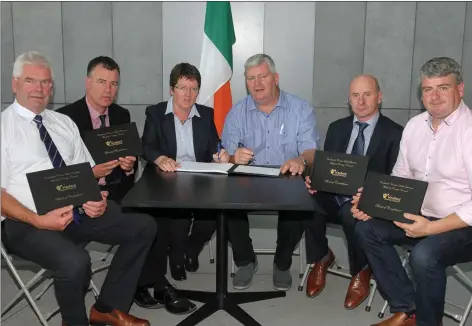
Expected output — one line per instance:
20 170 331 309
0 100 95 216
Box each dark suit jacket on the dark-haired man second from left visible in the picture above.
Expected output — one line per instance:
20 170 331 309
56 96 138 203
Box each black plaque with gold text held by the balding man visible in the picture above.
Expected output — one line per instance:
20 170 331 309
311 150 369 196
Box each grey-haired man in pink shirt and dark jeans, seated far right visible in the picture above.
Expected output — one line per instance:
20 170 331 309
351 57 472 326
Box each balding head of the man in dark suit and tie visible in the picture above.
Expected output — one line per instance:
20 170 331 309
349 75 382 122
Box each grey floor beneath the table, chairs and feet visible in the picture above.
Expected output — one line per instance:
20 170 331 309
1 244 472 326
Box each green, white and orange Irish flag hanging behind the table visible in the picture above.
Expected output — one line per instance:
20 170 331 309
197 2 236 135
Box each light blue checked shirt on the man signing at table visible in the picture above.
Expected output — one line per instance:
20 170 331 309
222 91 319 165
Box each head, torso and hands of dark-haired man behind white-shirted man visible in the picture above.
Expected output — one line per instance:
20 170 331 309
57 57 137 204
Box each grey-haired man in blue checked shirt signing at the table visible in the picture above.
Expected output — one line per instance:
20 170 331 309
222 54 319 291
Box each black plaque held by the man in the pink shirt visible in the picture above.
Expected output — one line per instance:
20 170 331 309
358 172 428 223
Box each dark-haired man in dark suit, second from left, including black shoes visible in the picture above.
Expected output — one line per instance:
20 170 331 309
57 56 197 313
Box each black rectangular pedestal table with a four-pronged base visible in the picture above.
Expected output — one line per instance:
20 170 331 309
121 164 313 326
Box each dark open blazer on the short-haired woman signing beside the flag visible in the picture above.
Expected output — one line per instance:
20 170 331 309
142 102 220 163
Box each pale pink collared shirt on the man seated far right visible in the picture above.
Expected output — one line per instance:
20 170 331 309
392 101 472 226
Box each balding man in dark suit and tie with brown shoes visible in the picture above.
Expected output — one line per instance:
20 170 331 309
305 75 403 309
